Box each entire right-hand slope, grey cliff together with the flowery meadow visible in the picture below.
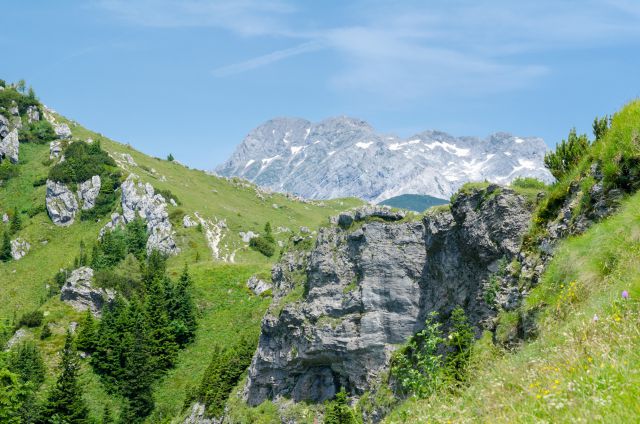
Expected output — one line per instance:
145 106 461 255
218 101 640 423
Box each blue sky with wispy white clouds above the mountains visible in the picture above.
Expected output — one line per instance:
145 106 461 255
0 0 640 169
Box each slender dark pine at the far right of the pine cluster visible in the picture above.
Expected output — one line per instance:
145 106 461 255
170 264 198 346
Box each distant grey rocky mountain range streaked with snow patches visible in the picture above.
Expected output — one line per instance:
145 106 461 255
215 117 553 202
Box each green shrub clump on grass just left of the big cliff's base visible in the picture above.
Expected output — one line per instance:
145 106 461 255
197 338 257 417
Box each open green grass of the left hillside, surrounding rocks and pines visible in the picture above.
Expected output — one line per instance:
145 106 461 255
0 95 361 422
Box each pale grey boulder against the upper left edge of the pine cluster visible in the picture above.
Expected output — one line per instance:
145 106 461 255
60 266 115 317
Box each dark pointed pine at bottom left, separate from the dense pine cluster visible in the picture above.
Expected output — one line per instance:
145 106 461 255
43 331 89 424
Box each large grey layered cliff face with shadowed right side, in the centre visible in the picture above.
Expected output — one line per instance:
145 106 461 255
245 186 530 405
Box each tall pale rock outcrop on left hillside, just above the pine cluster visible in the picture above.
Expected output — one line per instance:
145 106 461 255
122 174 180 255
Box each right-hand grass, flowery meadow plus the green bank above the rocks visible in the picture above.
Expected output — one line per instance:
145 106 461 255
386 101 640 423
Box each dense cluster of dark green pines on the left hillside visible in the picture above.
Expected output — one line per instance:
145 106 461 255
78 252 196 423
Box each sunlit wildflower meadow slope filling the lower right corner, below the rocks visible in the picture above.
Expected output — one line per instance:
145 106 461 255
386 187 640 423
